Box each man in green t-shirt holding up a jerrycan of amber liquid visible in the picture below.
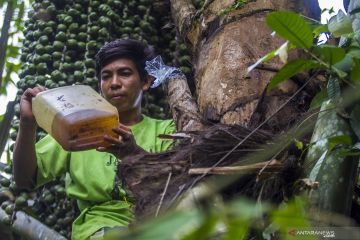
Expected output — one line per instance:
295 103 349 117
13 40 176 240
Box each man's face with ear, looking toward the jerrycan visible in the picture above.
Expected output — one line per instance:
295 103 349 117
100 58 150 112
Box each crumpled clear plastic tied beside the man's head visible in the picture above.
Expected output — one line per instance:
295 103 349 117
145 56 183 88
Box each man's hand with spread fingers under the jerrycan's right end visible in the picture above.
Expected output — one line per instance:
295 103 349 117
96 123 146 159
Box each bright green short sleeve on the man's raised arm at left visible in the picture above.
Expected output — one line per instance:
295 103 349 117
35 135 70 187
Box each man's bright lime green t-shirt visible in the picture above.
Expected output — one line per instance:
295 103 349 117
36 116 176 240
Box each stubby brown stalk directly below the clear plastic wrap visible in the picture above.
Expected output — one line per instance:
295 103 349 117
165 76 204 131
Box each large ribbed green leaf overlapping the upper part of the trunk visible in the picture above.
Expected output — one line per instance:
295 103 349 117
266 11 313 49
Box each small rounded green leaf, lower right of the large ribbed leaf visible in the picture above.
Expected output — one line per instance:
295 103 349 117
314 44 345 65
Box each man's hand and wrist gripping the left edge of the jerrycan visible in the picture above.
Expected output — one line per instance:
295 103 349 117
20 85 46 127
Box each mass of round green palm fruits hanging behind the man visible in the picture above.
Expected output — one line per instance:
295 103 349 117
0 0 192 237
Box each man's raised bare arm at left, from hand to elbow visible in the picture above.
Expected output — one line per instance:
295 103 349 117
13 86 45 189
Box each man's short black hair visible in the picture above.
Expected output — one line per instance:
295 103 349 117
95 39 155 81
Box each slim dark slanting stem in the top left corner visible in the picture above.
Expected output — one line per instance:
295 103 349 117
0 1 14 88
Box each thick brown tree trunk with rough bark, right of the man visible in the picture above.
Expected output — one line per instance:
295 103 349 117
171 0 320 130
